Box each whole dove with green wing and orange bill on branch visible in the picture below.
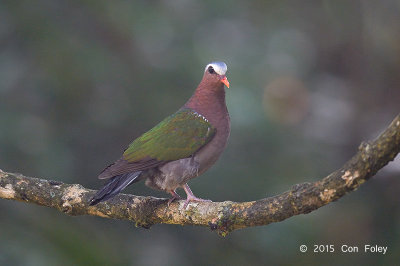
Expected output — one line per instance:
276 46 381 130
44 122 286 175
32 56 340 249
89 61 230 208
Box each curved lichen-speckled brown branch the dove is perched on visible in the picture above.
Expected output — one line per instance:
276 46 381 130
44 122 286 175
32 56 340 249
0 115 400 236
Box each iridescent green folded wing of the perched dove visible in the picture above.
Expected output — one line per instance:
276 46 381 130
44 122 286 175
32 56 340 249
123 109 216 163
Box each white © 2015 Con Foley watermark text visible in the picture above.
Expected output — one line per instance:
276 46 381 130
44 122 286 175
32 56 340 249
299 244 388 255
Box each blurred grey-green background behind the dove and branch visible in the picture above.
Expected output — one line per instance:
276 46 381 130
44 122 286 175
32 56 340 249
0 0 400 265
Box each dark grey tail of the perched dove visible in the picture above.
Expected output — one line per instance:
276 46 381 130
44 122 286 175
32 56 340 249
89 171 142 206
